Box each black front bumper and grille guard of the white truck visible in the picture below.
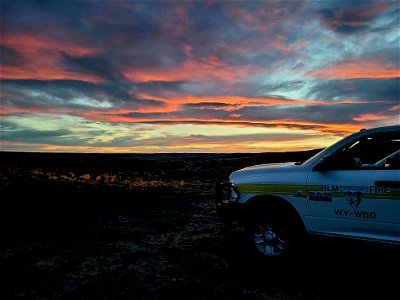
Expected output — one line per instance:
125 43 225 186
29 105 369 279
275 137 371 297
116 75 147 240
215 180 245 221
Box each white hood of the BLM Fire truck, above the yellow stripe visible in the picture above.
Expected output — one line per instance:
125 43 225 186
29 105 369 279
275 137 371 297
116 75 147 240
229 162 304 182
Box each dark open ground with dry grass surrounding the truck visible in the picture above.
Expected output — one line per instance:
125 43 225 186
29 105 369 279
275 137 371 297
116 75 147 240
0 151 400 299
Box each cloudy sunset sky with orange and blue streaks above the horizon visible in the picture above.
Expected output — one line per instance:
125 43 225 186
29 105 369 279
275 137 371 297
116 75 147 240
0 0 400 153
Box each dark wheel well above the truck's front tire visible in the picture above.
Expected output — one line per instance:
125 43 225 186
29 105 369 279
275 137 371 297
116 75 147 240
246 195 305 230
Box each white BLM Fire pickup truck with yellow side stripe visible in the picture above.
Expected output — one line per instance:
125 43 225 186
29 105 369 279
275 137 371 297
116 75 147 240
215 126 400 259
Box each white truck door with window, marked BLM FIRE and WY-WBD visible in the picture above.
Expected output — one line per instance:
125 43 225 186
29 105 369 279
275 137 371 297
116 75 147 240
307 132 400 242
